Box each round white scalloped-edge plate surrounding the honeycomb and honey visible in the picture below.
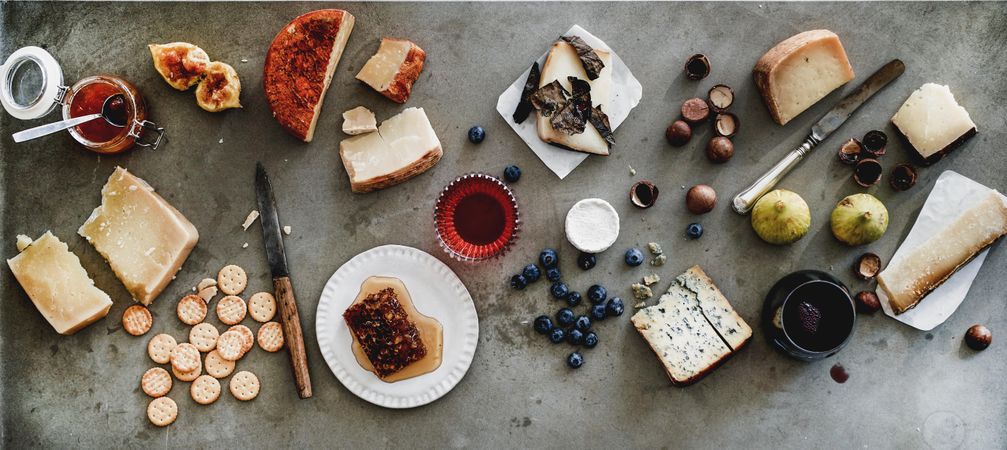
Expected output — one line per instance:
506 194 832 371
315 246 479 408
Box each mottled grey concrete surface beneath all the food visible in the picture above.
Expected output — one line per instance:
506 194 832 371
0 2 1007 448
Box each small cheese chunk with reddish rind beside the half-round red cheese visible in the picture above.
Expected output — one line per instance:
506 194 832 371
356 37 427 103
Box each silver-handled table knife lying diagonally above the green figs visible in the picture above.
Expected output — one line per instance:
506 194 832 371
731 59 905 214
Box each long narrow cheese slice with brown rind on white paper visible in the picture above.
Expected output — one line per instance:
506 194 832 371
877 190 1007 314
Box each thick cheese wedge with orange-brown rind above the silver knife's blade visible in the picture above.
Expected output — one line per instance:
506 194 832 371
752 29 853 125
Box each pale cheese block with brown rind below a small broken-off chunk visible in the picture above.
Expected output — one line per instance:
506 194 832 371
339 108 443 192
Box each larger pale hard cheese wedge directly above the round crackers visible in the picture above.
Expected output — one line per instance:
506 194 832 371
78 167 199 305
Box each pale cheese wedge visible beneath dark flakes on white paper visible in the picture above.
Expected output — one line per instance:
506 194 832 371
537 40 612 155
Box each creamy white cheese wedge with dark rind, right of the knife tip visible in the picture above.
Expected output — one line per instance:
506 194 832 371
891 83 976 163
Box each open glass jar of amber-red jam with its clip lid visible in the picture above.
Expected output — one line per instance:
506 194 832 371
0 46 164 154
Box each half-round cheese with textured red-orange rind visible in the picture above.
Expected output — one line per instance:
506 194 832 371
263 9 353 142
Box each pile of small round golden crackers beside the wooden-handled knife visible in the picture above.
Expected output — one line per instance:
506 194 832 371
123 265 283 427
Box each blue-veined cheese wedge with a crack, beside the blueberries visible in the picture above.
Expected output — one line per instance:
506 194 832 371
631 266 752 386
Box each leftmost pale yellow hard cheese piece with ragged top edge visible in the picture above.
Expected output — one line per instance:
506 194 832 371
7 232 112 334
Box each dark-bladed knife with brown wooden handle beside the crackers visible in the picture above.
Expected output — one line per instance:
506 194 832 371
255 163 311 399
